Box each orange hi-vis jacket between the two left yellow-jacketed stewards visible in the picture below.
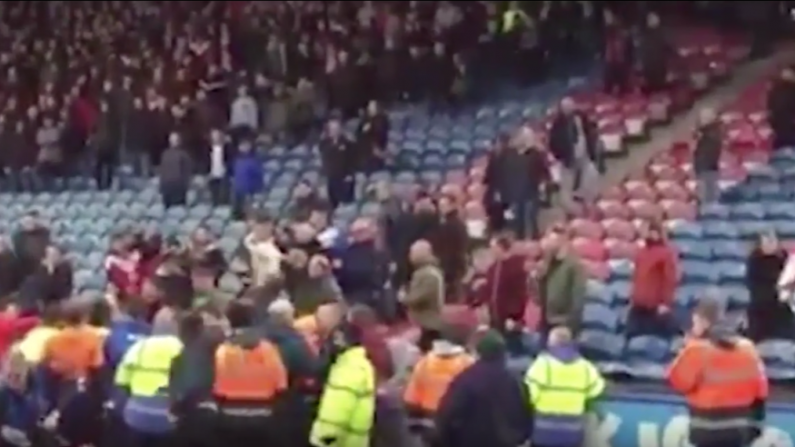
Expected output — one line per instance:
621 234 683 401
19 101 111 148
213 341 287 403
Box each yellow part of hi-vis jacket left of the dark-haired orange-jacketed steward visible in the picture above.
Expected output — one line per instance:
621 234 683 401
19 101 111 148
114 335 182 397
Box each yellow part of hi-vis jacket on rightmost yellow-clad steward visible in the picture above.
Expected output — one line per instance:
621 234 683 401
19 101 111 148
524 354 605 416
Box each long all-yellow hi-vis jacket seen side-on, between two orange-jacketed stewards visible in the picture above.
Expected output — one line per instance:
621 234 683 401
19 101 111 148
309 347 375 447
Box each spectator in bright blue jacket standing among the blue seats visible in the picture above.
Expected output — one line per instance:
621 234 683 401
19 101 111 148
232 140 265 219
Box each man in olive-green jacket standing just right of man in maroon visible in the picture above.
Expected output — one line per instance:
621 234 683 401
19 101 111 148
538 239 587 334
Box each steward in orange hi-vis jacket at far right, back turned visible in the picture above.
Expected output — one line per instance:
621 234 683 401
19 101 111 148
668 299 768 447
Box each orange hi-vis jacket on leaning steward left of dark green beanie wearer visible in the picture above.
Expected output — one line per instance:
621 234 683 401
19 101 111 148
403 352 475 416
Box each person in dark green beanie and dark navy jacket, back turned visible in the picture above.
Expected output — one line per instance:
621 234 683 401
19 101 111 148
435 329 532 447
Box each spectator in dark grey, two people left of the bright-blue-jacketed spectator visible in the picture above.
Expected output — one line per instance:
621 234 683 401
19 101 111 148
159 133 193 208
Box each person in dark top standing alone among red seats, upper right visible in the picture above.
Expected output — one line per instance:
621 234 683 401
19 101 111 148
693 108 723 204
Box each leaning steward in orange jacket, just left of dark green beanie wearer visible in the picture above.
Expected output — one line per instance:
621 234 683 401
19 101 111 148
403 326 475 436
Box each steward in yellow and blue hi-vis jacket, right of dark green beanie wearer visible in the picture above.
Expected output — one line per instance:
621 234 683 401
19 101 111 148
524 326 605 447
